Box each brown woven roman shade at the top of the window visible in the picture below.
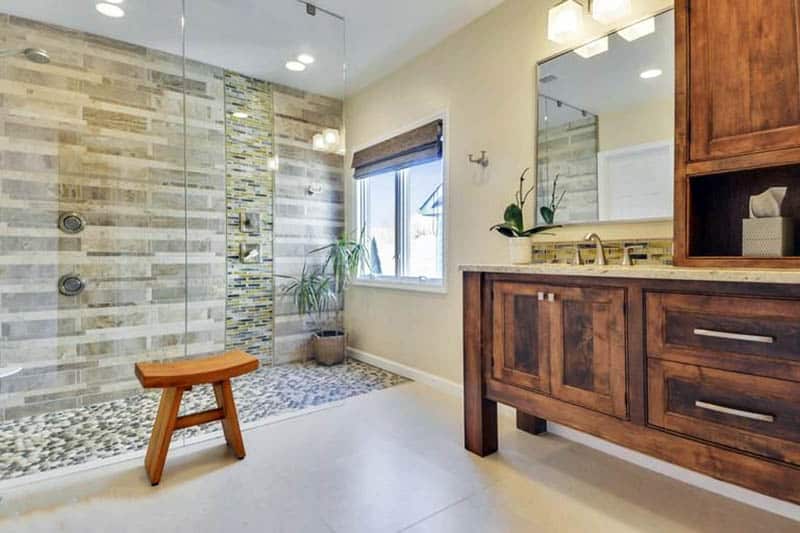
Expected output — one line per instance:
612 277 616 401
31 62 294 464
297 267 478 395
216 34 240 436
353 120 442 180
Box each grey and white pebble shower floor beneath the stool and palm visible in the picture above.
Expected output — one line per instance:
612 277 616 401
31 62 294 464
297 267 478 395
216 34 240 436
0 359 406 481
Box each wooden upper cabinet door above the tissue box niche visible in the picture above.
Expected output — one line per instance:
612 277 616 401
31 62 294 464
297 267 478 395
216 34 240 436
677 0 800 161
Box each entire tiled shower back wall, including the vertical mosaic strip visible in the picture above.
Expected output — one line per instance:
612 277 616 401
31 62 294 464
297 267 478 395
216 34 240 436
0 15 344 421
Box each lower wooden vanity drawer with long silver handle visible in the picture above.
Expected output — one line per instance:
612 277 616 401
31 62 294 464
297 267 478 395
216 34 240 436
648 359 800 465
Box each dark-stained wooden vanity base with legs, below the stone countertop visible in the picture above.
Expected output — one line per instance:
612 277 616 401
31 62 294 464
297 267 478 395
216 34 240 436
464 272 800 503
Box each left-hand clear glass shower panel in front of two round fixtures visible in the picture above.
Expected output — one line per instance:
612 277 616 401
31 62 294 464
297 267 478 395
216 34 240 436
0 0 186 420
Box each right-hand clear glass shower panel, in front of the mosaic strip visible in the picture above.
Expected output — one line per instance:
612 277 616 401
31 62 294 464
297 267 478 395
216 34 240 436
186 0 345 366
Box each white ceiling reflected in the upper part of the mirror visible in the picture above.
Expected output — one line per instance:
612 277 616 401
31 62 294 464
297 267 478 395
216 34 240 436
538 11 675 126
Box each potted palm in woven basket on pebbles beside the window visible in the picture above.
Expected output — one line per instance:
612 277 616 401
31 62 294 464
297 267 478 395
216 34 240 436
280 230 371 365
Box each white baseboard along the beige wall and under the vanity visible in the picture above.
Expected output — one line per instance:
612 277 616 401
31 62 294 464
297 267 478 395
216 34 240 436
347 342 800 521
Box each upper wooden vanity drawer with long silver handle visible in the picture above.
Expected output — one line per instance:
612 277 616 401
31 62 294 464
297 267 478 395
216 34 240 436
647 293 800 380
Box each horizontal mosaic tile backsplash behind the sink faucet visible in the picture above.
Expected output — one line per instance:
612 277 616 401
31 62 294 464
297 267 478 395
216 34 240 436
533 239 672 265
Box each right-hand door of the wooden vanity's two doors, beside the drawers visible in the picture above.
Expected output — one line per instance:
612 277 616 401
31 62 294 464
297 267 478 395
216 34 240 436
546 288 627 418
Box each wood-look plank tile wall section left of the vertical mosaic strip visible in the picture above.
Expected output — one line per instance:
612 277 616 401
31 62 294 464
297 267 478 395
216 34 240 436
0 15 225 419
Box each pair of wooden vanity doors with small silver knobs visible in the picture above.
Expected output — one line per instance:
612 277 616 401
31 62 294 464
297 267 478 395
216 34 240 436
492 282 627 418
